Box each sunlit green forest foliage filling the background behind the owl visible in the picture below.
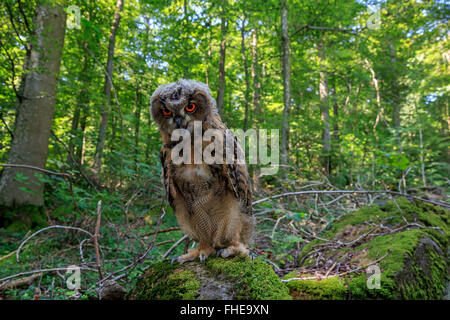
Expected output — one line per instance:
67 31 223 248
0 0 450 298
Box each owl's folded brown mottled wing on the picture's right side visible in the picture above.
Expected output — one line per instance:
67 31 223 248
223 132 253 215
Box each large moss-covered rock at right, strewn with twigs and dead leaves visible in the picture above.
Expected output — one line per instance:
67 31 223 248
285 198 450 299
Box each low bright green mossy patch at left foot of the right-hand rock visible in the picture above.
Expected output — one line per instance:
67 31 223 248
284 272 348 300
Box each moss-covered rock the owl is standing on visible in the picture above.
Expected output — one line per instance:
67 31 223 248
127 257 291 300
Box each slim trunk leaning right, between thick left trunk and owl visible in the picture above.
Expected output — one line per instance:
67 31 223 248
93 0 124 177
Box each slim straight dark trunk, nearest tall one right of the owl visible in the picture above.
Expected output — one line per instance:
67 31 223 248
281 0 291 177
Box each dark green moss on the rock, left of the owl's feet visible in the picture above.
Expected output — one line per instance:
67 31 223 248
127 262 200 300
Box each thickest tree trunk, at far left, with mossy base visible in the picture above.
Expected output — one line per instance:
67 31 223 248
0 2 66 207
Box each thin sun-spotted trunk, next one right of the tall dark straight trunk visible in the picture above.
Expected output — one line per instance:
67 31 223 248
317 40 331 176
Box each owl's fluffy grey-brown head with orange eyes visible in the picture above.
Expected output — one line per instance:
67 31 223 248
150 80 217 136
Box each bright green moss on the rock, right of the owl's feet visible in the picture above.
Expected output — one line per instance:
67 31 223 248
206 257 291 300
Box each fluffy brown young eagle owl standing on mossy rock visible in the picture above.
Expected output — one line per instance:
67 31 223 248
150 80 254 263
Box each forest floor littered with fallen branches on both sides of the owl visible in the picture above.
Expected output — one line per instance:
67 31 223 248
0 183 448 299
